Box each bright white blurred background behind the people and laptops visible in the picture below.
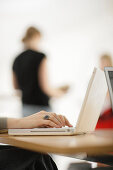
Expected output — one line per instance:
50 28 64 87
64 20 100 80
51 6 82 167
0 0 113 170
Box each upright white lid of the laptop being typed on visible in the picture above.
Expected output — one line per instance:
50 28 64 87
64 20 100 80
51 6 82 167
75 68 108 133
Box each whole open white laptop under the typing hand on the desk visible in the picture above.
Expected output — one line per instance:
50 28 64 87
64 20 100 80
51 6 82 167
8 68 108 135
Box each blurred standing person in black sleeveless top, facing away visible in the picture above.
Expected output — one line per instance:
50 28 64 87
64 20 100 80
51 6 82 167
13 27 68 116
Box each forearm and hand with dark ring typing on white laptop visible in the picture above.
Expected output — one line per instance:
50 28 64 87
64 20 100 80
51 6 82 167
0 111 72 130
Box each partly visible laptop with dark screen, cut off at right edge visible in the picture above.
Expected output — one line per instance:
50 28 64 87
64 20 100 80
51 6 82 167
104 67 113 110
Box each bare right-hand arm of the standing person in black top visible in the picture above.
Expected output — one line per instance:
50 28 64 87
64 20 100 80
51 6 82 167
38 58 69 97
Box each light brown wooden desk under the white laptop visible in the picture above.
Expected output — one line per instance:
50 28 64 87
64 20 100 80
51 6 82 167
0 130 113 155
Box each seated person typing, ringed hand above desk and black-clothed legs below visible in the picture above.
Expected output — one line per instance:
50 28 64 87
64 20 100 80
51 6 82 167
0 111 72 170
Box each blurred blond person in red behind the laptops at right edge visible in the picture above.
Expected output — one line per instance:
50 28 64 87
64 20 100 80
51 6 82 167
96 54 113 129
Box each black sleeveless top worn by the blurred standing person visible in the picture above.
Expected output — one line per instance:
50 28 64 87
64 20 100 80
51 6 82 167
13 50 49 106
